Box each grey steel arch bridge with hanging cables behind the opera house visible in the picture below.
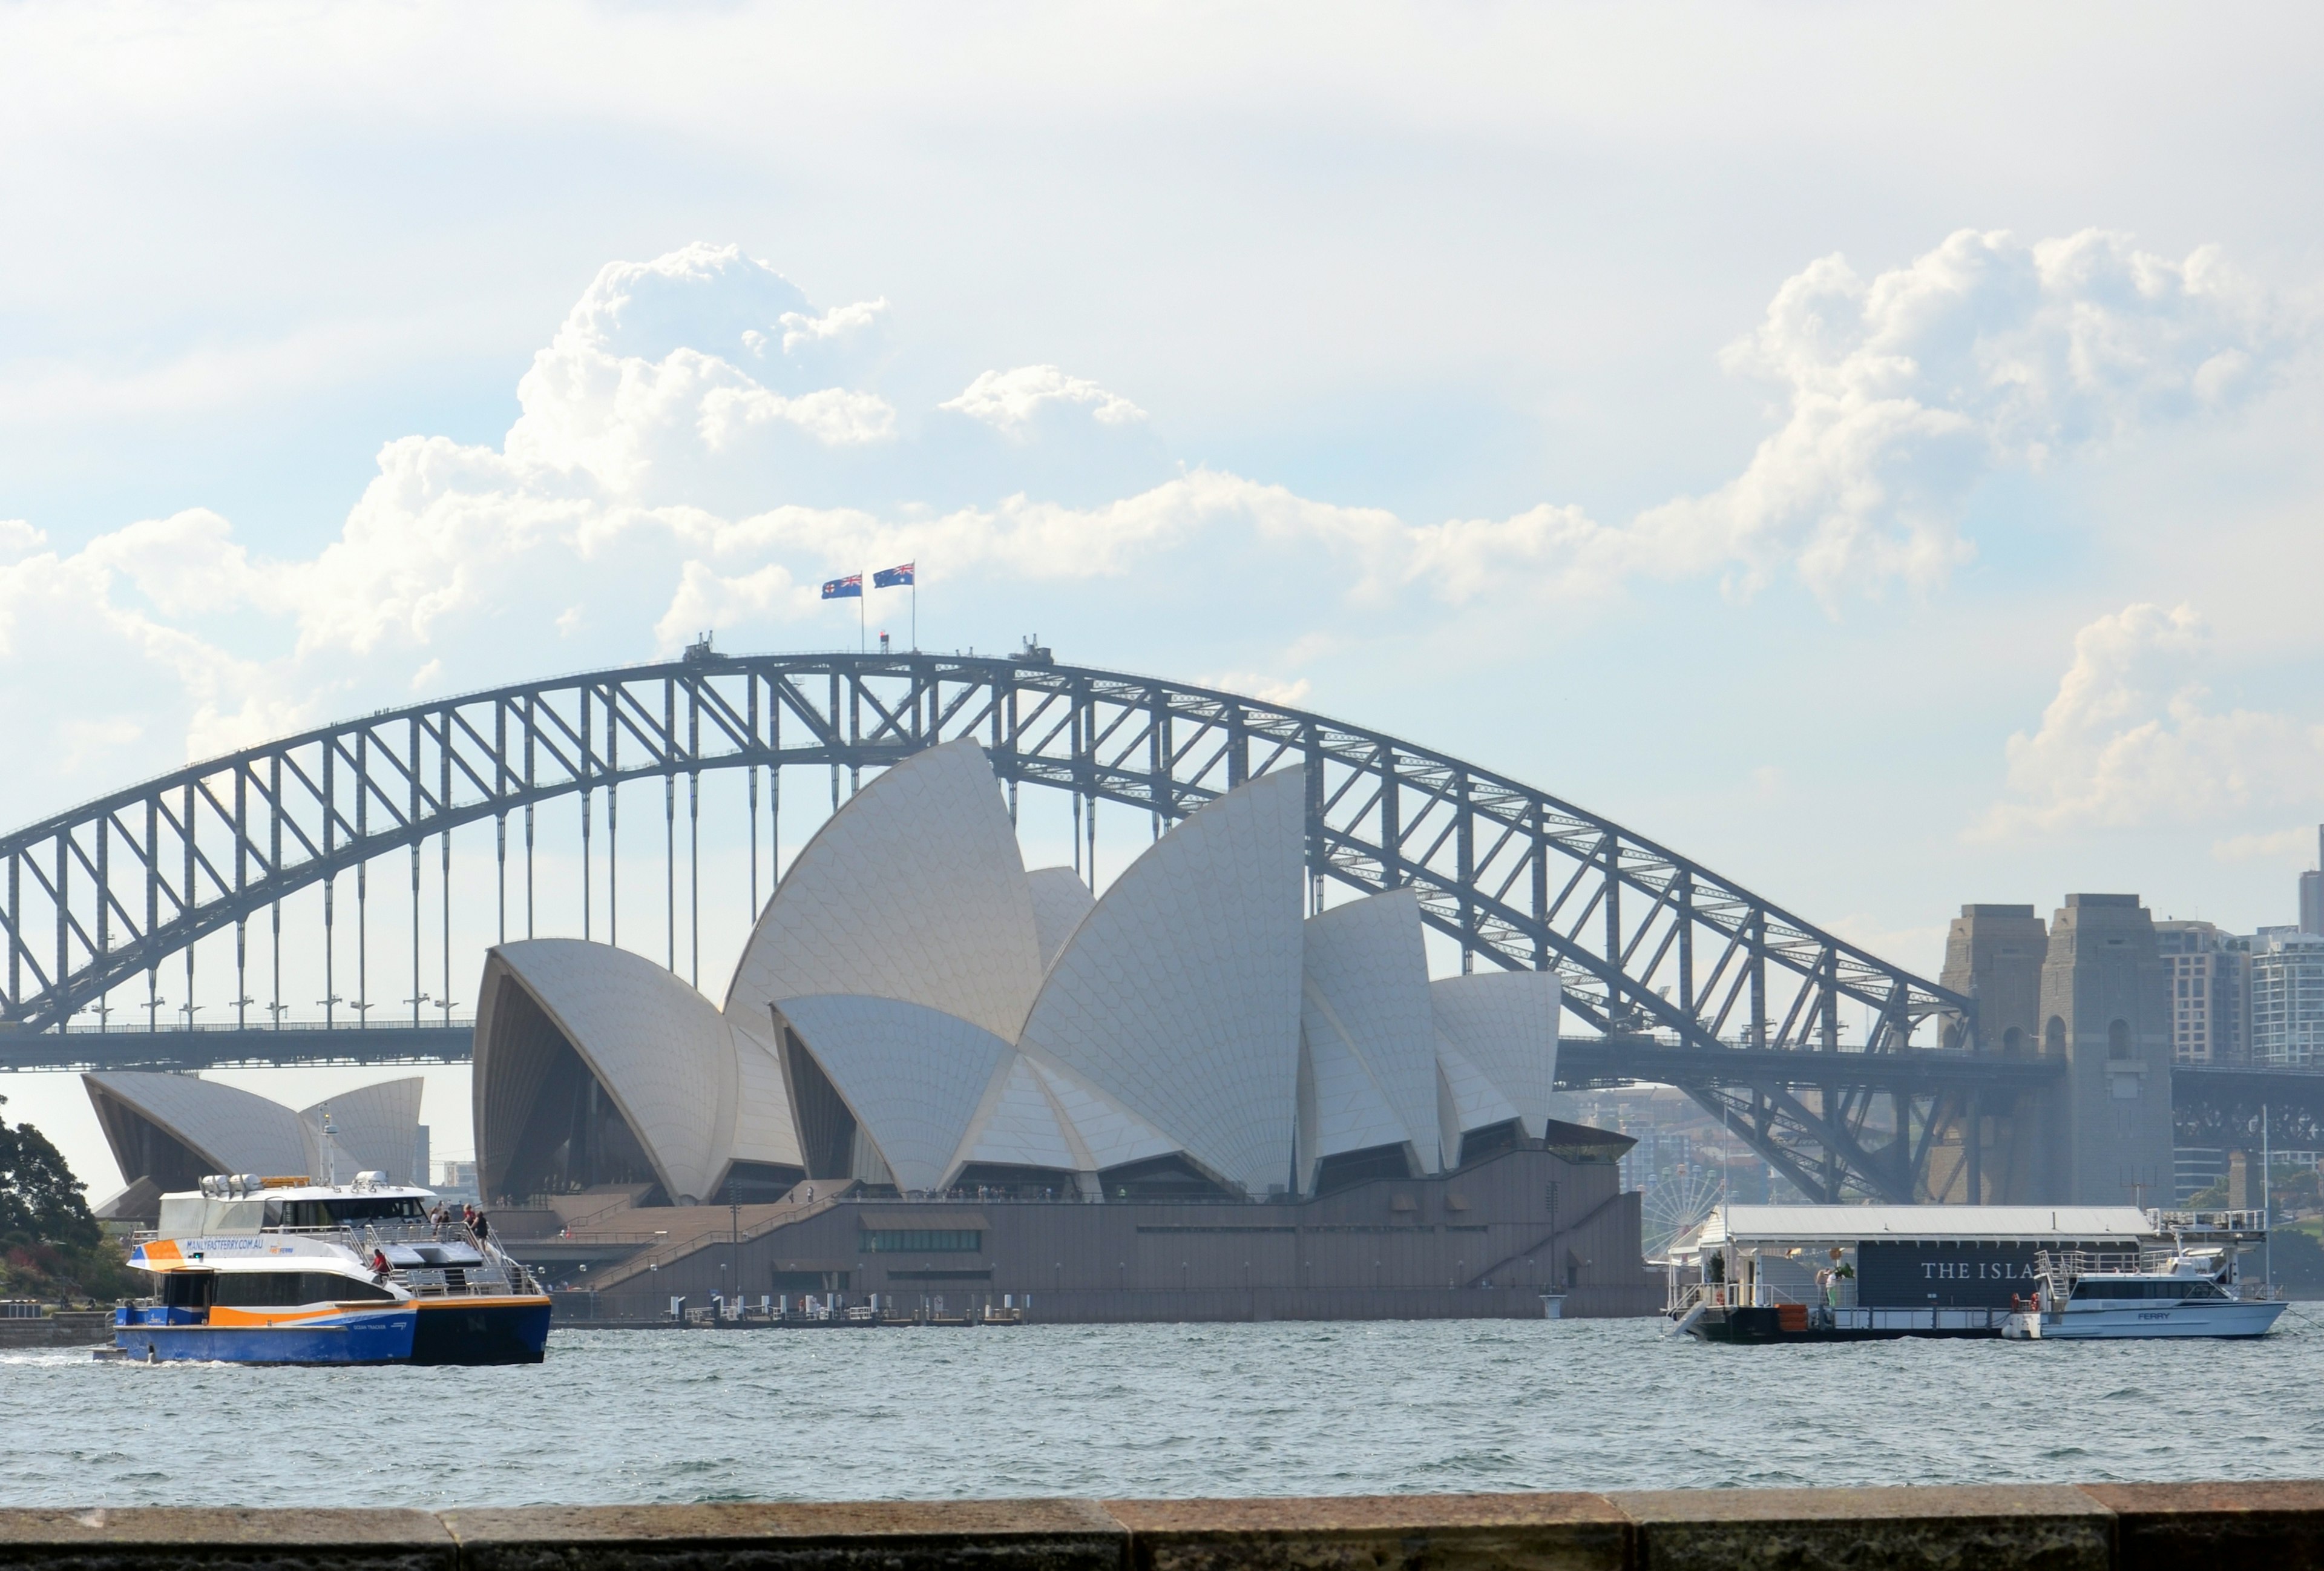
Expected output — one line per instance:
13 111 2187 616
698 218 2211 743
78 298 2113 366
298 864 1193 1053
0 639 2324 1202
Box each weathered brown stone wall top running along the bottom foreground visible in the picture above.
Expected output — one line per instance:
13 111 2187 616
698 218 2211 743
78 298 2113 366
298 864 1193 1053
0 1480 2324 1571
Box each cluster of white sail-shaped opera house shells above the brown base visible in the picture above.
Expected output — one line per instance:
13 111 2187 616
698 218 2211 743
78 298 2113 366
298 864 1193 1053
474 742 1560 1204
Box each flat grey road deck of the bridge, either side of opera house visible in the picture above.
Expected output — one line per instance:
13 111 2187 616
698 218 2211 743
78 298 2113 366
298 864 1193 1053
0 1020 2324 1129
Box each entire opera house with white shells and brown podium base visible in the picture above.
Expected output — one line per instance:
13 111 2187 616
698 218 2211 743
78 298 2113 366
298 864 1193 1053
474 742 1652 1320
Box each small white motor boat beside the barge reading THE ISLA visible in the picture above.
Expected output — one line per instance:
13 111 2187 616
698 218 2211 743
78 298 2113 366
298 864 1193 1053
2001 1248 2285 1341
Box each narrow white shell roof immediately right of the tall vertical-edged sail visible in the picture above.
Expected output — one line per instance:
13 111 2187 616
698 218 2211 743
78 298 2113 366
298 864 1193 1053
1301 890 1436 1167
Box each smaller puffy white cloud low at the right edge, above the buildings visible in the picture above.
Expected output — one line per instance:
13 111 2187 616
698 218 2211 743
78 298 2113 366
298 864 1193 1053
1973 604 2324 848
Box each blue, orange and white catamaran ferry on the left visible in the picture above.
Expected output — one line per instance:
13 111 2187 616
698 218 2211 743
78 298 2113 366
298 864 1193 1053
114 1174 548 1364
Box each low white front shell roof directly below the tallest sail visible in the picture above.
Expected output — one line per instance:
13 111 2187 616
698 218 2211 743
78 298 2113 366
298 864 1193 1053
778 995 1016 1190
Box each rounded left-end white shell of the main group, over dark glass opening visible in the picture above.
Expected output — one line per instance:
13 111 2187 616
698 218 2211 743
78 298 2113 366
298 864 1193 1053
474 939 737 1202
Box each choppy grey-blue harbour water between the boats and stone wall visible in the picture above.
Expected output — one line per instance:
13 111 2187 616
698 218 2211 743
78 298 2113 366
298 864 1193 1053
0 1306 2324 1506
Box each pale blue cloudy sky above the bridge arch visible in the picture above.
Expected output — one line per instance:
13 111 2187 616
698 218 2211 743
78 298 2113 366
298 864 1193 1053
0 2 2324 1190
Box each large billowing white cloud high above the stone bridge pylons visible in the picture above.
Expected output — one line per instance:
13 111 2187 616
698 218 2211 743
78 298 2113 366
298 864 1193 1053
1534 230 2301 604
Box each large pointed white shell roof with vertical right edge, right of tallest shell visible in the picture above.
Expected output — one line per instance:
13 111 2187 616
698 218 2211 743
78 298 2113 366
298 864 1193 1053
1023 769 1306 1194
